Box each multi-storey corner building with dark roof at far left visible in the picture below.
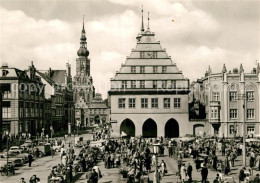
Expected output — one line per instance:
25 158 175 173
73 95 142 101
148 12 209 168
0 63 45 136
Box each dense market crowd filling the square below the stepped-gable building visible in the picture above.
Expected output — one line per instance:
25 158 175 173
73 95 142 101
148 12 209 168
15 124 260 183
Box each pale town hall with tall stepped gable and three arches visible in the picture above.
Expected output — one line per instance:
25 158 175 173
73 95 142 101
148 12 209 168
109 11 193 137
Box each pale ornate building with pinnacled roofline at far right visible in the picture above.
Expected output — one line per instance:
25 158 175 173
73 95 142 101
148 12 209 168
192 64 260 138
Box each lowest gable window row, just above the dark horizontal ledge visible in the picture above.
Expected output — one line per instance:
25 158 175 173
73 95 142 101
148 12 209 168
121 80 176 89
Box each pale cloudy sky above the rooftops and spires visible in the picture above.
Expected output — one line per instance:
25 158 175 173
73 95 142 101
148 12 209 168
0 0 260 98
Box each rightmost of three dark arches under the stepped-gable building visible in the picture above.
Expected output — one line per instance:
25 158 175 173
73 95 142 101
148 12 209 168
165 119 180 138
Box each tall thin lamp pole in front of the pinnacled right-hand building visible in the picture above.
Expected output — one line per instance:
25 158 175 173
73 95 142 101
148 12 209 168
236 94 247 167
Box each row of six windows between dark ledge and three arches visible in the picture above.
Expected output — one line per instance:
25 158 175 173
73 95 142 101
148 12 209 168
118 98 181 109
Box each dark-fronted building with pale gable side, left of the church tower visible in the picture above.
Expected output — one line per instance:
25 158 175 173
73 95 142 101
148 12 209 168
37 63 75 133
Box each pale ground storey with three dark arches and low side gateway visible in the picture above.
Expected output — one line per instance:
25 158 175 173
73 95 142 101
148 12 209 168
111 114 205 138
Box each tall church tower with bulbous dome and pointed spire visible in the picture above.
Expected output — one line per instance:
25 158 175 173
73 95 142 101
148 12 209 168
73 18 95 104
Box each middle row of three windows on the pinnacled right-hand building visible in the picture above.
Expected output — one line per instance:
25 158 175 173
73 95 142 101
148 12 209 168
211 107 255 119
